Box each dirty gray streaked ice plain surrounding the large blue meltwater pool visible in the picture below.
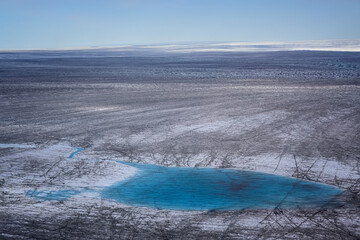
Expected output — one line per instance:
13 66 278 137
0 43 360 239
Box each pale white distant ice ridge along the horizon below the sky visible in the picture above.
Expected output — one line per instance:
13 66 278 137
0 39 360 53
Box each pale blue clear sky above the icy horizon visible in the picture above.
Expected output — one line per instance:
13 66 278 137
0 0 360 49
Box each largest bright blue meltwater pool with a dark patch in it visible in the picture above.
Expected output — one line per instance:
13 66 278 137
101 161 342 210
